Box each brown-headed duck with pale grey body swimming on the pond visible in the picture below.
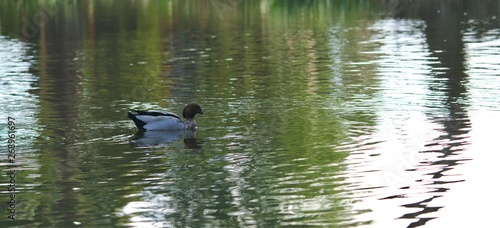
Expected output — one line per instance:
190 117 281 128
128 103 205 131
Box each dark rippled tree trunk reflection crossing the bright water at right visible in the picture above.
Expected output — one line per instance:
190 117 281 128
386 1 476 227
